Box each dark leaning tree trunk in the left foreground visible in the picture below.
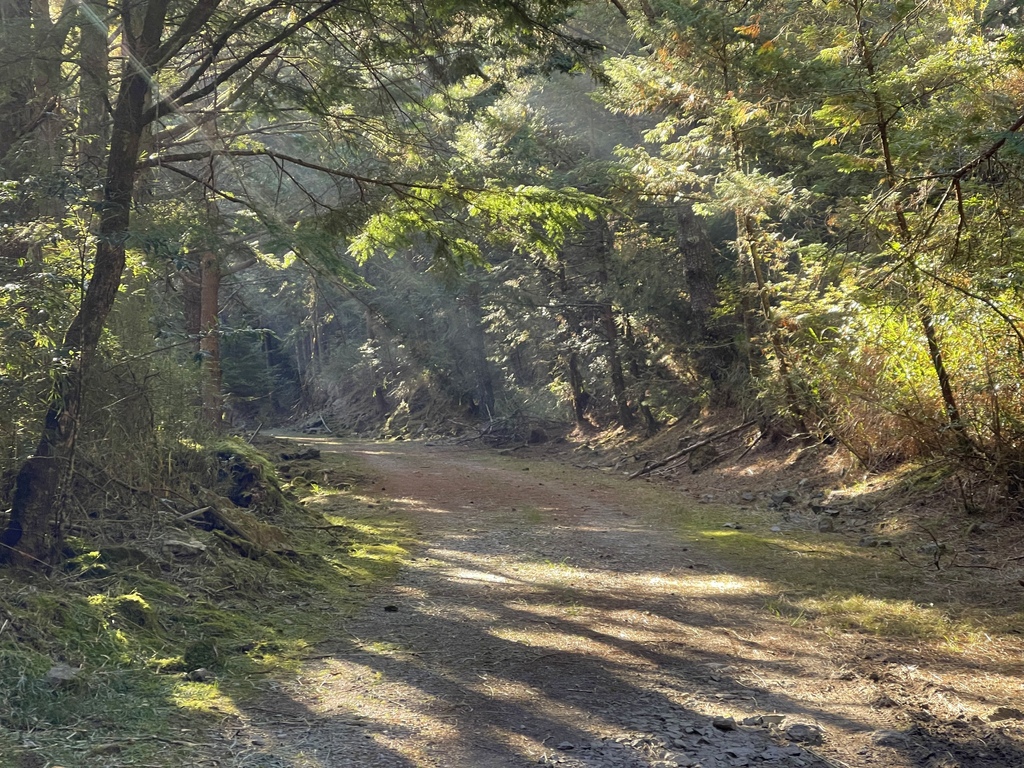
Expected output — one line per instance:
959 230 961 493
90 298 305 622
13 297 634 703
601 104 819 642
0 0 170 565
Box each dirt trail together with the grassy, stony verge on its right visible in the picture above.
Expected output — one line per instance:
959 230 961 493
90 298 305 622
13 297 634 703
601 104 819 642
207 435 1024 768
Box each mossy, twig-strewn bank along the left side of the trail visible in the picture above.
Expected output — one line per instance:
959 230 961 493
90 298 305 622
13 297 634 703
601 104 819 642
0 441 411 768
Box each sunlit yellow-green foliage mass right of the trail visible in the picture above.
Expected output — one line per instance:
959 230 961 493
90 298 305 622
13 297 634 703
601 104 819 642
593 0 1022 475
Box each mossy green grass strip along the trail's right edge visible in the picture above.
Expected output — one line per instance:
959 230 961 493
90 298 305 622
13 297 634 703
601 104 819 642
495 460 1024 651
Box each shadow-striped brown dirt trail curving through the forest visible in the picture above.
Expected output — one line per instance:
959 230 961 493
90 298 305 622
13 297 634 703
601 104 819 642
222 437 1024 768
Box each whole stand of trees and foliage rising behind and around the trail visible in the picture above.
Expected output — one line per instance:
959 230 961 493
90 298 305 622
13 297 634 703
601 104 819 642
0 0 1024 562
